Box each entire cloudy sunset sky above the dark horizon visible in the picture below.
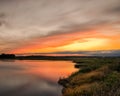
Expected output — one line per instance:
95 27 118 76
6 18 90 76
0 0 120 55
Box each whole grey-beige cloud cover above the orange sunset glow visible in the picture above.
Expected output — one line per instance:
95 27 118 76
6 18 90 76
0 0 120 50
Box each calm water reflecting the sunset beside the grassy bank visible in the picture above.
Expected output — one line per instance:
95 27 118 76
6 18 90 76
0 60 76 96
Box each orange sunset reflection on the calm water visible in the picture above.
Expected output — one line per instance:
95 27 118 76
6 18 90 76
18 60 76 81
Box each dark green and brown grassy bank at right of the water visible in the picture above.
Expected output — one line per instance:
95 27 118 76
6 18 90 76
58 57 120 96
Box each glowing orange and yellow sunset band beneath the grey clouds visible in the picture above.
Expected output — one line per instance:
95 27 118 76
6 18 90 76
10 29 120 54
